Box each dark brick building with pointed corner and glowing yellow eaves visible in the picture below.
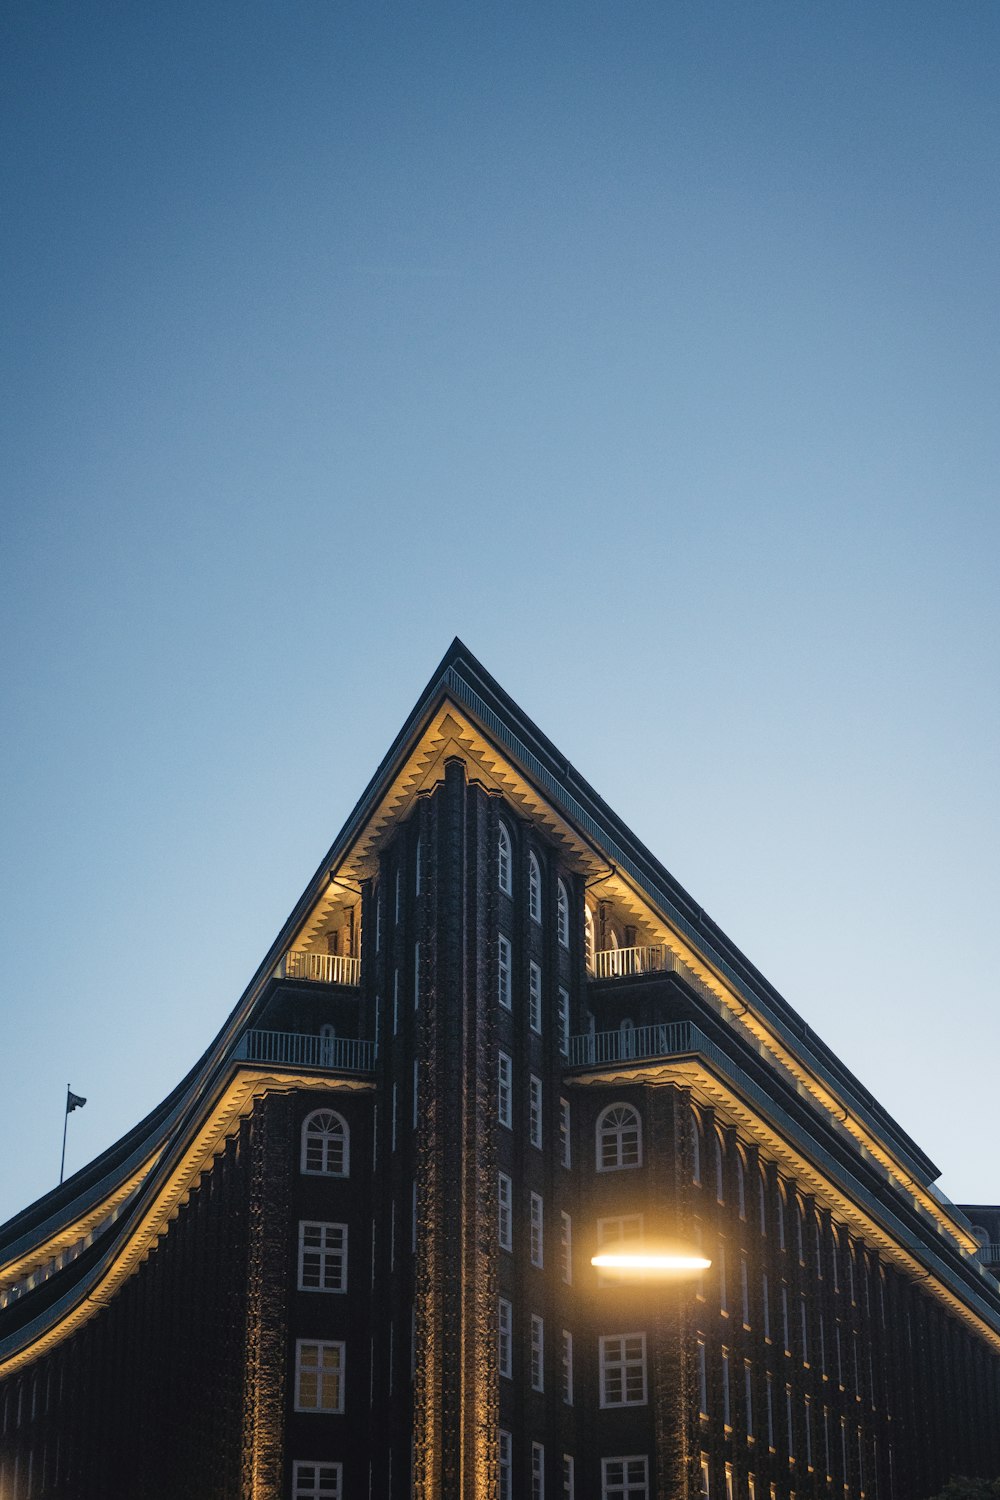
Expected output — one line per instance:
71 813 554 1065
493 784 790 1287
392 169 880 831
0 642 1000 1500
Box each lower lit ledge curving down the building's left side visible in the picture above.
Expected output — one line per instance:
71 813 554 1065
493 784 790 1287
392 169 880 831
0 1050 375 1377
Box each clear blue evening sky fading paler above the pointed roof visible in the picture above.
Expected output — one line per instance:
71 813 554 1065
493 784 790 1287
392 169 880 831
0 0 1000 1220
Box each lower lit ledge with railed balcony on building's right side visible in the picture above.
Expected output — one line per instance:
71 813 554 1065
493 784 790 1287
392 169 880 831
567 1022 1000 1350
